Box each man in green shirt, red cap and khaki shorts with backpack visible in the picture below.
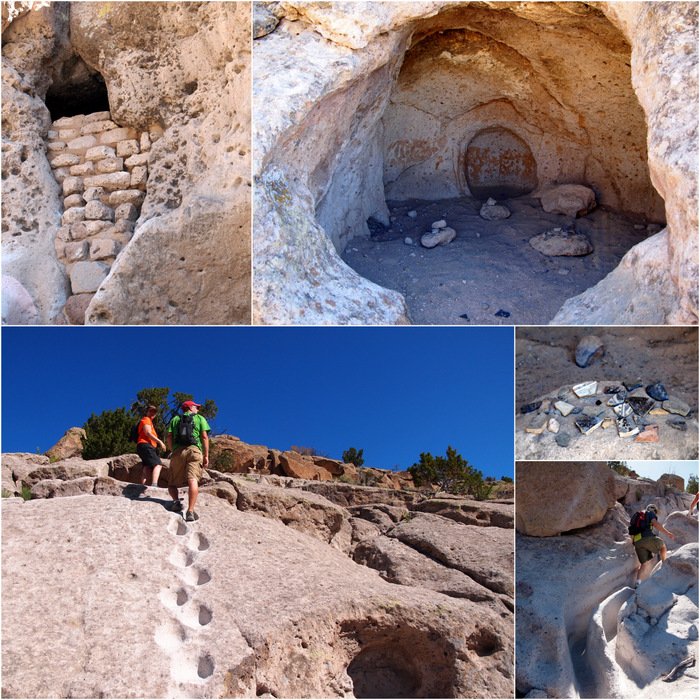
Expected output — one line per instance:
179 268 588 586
167 401 210 522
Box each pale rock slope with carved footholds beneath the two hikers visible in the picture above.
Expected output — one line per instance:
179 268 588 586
2 454 513 697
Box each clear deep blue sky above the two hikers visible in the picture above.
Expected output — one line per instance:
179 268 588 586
2 326 513 478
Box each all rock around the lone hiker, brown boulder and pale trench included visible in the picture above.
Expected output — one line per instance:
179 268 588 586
516 462 698 698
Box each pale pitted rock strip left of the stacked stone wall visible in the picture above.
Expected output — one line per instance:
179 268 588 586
2 3 70 324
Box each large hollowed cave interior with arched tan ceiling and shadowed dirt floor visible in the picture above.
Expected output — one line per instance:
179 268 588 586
336 5 665 325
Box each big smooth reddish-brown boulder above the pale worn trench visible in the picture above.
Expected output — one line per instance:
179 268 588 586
515 462 627 537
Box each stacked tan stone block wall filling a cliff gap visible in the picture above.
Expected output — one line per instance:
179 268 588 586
47 112 162 324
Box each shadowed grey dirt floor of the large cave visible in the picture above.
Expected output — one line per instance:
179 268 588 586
343 197 647 325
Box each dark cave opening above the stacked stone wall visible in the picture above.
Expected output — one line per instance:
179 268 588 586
45 56 110 122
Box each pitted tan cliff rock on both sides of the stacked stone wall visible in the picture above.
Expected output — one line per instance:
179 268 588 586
3 2 250 324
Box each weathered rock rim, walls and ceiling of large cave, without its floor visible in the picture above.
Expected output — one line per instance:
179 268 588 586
253 2 698 323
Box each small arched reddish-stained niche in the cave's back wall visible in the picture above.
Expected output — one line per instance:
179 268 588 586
465 126 537 199
